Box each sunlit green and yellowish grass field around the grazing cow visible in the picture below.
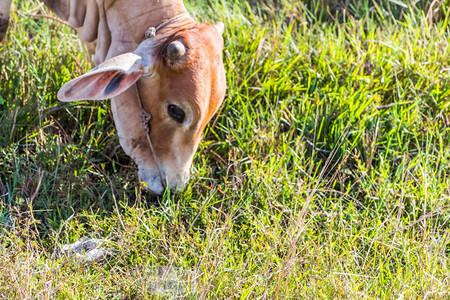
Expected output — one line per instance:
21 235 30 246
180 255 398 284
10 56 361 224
0 0 450 299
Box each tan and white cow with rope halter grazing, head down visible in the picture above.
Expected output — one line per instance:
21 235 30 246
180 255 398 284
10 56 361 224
0 0 226 195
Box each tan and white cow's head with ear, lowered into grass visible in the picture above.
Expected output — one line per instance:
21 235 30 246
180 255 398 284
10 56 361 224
58 23 226 194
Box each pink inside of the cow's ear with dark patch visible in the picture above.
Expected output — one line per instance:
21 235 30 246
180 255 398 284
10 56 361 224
58 70 141 102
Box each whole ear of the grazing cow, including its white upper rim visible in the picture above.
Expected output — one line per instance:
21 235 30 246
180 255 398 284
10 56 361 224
57 53 149 102
